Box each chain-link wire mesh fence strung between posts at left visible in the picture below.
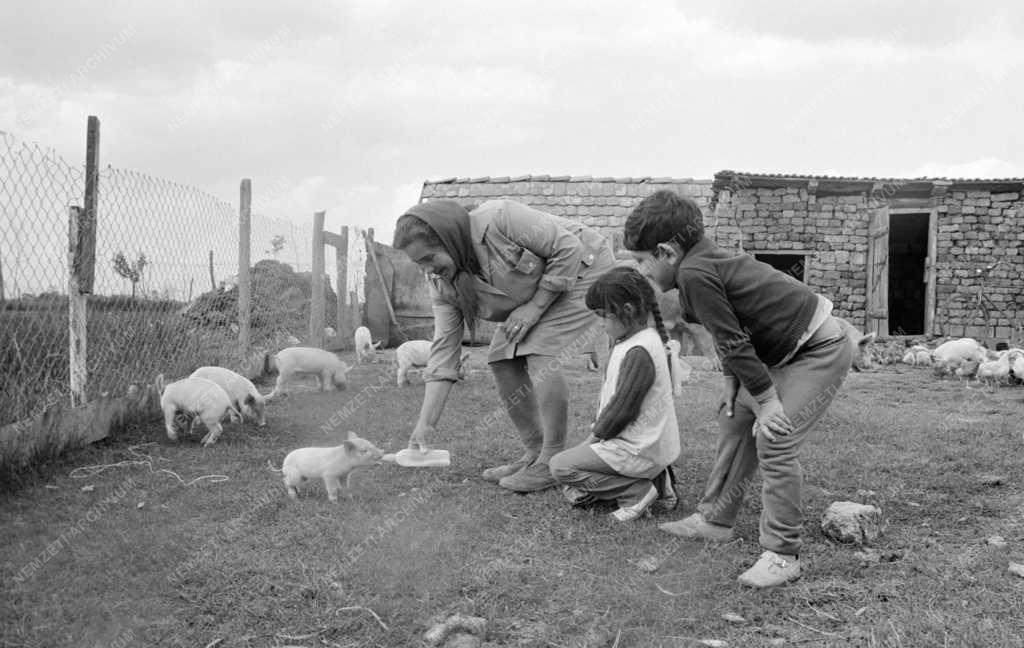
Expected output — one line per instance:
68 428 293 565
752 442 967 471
0 132 323 426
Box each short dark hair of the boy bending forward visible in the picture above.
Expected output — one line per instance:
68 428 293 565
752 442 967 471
623 189 703 252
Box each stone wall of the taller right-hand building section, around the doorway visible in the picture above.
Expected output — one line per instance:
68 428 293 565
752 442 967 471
716 177 1024 345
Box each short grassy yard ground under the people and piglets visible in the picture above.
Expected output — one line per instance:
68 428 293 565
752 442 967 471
0 352 1024 648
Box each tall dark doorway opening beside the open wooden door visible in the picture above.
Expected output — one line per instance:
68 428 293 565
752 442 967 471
889 214 929 335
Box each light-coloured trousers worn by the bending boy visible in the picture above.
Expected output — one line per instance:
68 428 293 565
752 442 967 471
697 316 853 555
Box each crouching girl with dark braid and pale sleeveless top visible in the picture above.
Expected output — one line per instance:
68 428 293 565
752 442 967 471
550 267 680 522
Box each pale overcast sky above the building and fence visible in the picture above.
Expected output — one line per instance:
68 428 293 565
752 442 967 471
0 0 1024 244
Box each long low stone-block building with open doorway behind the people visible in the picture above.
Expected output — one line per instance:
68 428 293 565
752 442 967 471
421 171 1024 343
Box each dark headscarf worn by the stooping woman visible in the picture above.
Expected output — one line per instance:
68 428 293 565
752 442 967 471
406 201 480 335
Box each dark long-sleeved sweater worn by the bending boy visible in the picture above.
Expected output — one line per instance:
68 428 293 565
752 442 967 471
676 239 818 397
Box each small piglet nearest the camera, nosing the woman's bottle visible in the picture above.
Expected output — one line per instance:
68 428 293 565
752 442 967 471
267 432 384 502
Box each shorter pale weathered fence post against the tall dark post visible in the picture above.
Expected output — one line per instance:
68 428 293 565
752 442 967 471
68 206 95 407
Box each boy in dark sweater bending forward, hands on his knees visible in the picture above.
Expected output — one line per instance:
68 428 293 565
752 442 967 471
625 190 852 588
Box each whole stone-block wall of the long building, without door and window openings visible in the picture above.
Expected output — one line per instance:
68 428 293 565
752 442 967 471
421 171 1024 344
